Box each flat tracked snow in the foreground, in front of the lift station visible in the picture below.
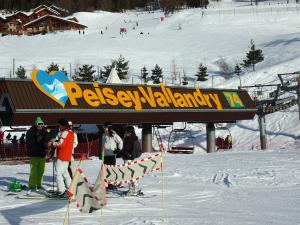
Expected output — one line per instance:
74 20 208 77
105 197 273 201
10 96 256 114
0 150 300 225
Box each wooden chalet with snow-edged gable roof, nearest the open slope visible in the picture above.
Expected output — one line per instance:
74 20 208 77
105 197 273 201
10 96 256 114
24 15 87 34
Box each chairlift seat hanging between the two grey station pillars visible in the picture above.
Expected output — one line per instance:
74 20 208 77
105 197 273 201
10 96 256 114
167 122 195 154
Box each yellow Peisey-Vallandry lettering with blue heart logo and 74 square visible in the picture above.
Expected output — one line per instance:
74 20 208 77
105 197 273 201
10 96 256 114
32 70 244 111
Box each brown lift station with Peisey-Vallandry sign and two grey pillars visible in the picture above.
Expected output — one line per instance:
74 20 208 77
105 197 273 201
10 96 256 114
0 74 257 152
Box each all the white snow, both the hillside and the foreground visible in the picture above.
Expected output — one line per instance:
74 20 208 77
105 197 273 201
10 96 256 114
0 1 300 225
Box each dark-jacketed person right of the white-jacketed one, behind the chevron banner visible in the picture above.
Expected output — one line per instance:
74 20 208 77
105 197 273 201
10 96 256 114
121 126 143 195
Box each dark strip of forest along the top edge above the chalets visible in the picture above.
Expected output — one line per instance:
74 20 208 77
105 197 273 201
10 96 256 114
0 0 208 13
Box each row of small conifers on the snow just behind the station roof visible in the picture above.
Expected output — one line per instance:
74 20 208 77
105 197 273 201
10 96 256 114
16 40 264 86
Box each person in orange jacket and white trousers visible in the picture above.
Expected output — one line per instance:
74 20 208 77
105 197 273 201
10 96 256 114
50 118 74 197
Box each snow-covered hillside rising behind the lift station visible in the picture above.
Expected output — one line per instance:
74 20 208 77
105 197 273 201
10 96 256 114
0 1 300 149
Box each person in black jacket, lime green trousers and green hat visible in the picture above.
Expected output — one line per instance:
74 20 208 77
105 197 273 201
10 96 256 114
26 117 48 190
